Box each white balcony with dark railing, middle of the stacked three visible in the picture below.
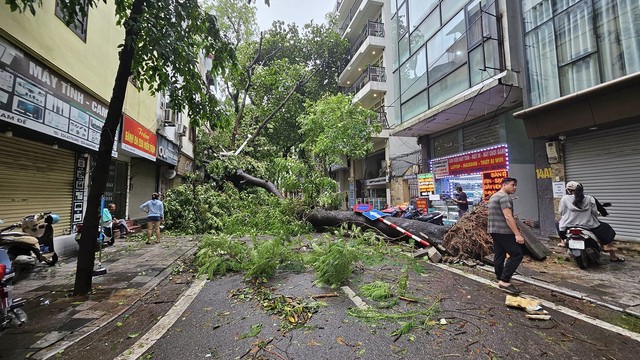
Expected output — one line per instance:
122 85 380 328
338 21 385 86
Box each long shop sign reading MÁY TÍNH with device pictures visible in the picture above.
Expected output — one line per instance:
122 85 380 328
0 37 118 156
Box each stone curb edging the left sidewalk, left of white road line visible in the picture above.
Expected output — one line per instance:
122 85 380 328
31 244 196 360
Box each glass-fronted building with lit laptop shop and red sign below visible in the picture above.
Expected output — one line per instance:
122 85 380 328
358 0 538 222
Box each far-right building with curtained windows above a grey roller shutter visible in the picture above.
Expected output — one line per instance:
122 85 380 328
515 0 640 241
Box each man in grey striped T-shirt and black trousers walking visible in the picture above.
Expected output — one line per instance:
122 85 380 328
487 177 524 295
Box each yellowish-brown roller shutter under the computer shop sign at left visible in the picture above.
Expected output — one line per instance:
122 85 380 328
0 135 75 236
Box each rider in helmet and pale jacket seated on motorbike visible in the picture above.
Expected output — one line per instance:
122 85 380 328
558 181 624 262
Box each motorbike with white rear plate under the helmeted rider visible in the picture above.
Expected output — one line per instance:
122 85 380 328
565 200 611 269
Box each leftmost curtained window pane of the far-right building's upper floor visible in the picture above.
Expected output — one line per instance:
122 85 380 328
524 22 560 105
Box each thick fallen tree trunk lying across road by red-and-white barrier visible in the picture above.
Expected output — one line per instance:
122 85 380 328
306 209 449 244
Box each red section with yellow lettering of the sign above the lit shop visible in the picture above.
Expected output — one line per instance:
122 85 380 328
447 145 509 176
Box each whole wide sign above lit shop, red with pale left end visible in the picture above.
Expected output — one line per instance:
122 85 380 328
431 145 509 178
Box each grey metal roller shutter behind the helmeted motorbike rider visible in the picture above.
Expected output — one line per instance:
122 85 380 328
564 125 640 241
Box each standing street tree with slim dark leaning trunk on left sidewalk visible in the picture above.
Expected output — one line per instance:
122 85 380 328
6 0 234 295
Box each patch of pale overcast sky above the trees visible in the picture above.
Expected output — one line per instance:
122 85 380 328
256 0 336 30
